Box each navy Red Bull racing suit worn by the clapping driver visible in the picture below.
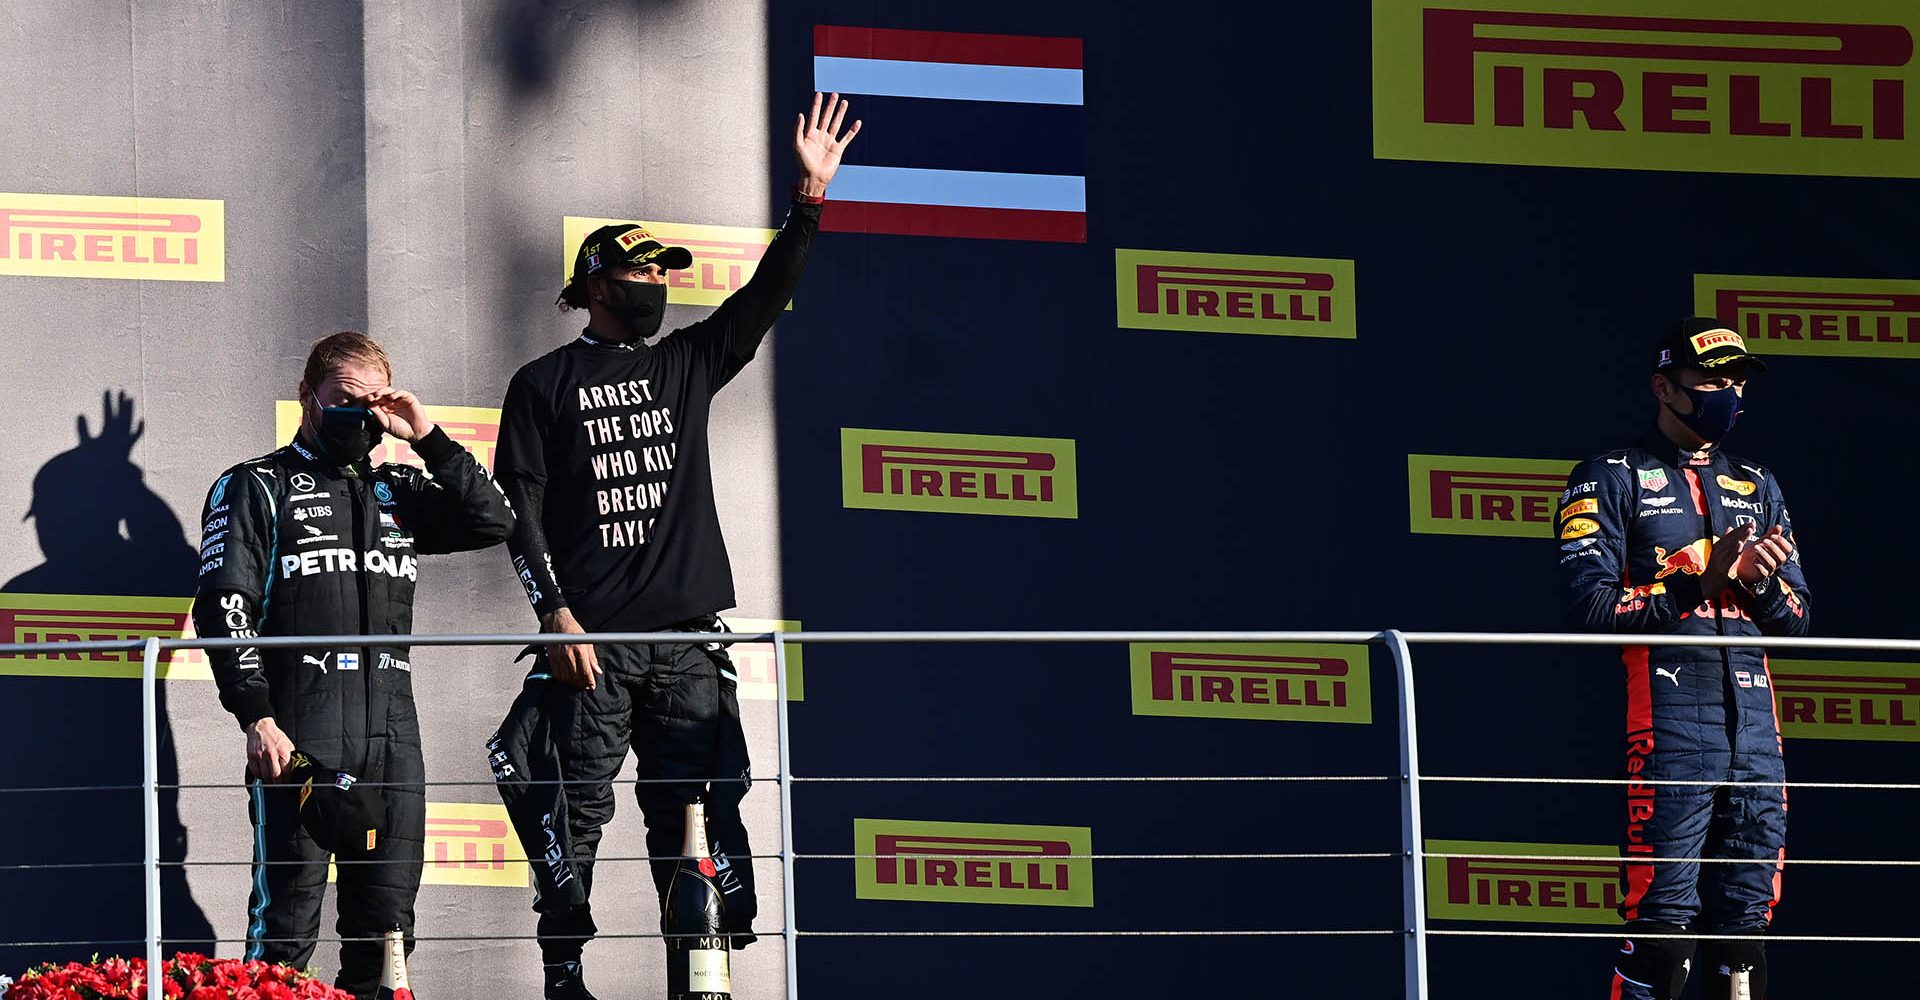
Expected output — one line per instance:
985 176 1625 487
1559 430 1812 998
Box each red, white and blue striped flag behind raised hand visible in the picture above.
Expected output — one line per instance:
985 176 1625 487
814 25 1087 244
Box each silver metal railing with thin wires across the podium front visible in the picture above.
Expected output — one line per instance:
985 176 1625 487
0 630 1920 1000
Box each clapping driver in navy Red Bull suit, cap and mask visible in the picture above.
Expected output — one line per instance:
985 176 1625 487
1557 317 1812 1000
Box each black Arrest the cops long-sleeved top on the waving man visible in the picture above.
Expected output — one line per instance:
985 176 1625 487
495 202 820 631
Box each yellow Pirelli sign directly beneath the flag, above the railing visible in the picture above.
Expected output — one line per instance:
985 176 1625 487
841 428 1079 518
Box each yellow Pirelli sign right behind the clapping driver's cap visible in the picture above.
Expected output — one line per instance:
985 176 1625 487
1693 274 1920 357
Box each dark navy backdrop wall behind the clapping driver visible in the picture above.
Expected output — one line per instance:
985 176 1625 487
770 0 1920 998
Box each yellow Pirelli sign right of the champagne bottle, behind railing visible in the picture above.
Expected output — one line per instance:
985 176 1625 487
852 820 1092 906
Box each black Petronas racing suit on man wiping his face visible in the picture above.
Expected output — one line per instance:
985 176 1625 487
194 428 513 998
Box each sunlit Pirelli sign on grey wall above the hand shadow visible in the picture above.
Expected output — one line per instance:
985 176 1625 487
0 194 227 282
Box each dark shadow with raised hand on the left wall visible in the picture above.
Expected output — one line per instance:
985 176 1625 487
0 392 213 973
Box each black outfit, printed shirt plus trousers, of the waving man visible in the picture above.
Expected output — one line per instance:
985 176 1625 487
488 190 820 965
